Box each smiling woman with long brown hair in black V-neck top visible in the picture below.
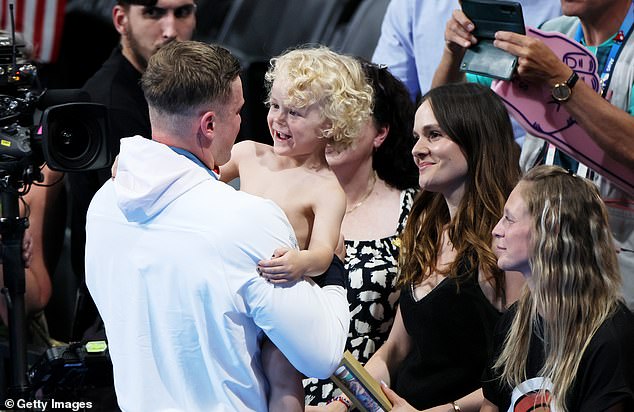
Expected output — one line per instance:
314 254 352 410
316 84 520 412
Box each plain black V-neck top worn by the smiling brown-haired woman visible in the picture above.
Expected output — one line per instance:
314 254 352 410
392 264 501 409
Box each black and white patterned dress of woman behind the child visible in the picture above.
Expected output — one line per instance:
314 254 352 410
304 189 416 405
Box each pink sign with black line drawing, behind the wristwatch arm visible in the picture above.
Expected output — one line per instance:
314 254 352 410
492 27 634 194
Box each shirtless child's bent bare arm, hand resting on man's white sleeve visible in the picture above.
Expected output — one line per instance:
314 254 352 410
258 183 346 283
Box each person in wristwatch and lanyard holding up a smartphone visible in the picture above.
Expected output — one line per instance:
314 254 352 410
434 0 634 310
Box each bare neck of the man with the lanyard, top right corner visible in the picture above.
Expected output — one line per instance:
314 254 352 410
579 0 632 46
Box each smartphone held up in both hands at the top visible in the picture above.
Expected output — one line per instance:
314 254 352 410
460 0 526 80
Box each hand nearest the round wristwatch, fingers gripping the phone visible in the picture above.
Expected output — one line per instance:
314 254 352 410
493 31 572 87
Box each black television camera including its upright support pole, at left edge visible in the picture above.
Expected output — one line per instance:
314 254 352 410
0 28 111 399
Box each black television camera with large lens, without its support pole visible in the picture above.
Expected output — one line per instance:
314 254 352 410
0 34 112 184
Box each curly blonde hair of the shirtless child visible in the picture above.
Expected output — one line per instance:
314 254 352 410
265 46 374 151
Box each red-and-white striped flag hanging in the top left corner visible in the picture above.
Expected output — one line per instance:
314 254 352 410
0 0 66 63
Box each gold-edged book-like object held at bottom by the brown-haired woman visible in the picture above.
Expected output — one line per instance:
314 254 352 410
330 351 392 412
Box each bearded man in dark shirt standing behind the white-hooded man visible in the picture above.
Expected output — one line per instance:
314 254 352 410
69 0 196 339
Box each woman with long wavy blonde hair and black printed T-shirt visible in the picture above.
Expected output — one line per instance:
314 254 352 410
482 166 634 412
